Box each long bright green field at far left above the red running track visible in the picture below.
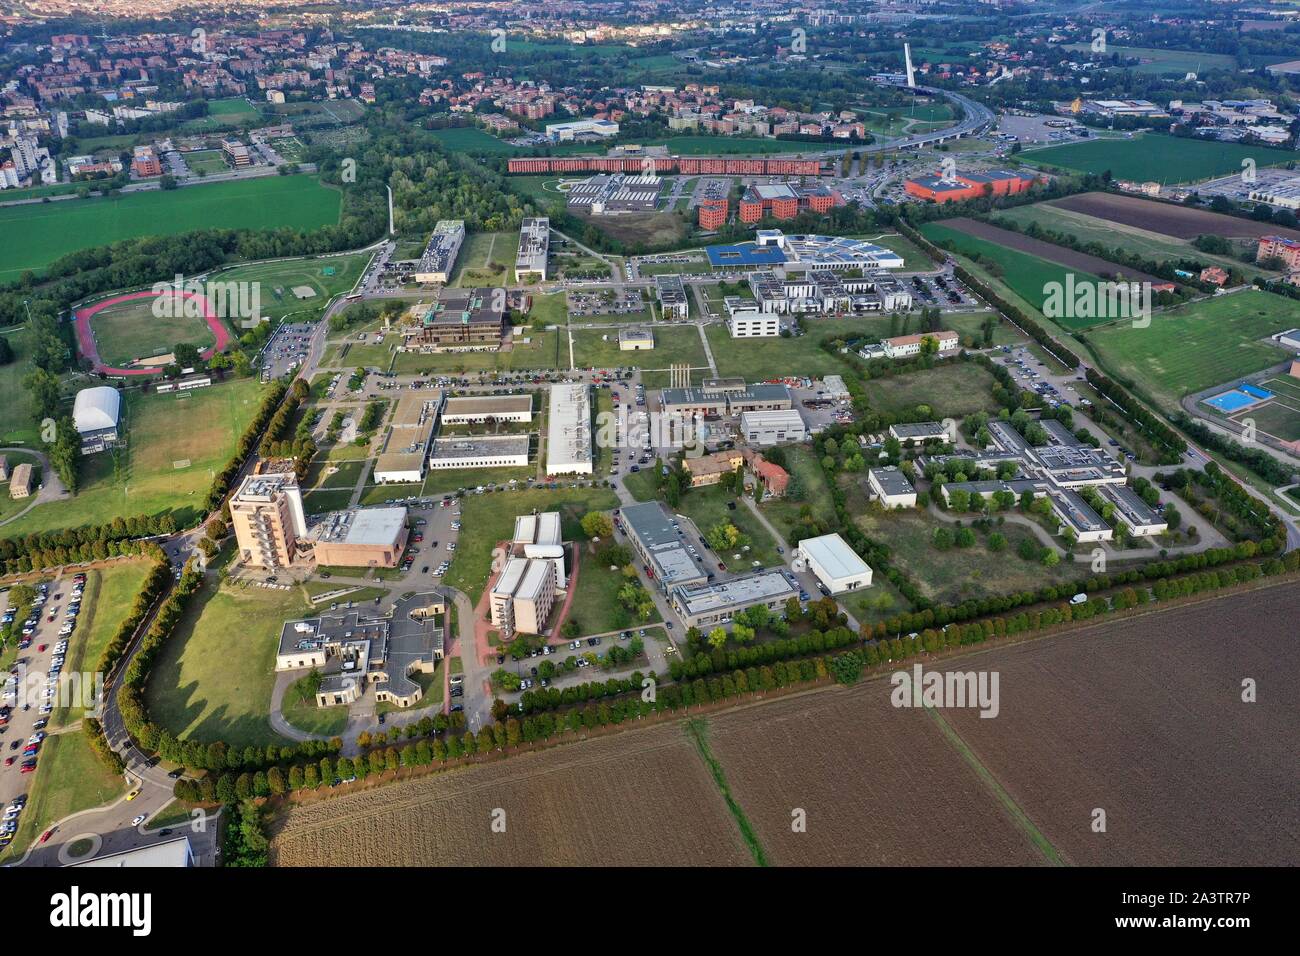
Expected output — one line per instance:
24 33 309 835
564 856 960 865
0 176 342 281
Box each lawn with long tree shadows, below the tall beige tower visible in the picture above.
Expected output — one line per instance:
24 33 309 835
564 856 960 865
146 575 313 747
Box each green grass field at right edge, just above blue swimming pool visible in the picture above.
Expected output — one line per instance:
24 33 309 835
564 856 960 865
1088 290 1296 408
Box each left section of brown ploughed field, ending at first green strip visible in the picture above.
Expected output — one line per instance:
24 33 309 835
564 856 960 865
272 723 751 866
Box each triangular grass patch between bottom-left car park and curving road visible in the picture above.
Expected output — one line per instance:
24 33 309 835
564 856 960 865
0 731 126 864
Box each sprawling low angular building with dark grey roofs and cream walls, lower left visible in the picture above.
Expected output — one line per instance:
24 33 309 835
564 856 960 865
276 592 447 708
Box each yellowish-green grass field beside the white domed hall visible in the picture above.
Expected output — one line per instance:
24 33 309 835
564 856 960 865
5 378 261 535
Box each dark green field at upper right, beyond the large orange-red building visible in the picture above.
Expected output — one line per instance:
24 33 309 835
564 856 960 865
1021 133 1295 183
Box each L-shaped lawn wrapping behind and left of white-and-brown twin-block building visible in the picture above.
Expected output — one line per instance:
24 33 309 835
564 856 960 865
443 488 619 604
